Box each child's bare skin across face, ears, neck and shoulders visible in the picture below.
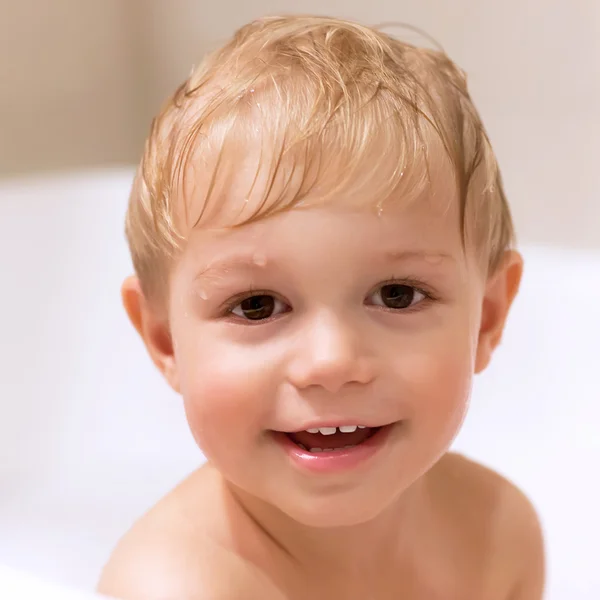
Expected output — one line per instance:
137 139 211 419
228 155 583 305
99 156 544 600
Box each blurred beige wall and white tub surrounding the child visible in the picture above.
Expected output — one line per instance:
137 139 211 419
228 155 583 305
0 0 600 600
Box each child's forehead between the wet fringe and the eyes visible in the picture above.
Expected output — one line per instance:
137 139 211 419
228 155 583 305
180 184 465 275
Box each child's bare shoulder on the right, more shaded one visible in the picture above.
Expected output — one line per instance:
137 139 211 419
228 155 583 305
437 454 544 600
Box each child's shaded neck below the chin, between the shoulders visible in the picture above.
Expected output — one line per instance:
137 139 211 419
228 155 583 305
224 478 429 576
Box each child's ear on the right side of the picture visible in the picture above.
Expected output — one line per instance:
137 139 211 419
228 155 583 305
475 250 523 373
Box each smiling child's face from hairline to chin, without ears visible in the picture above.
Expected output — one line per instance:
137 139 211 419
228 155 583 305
161 172 487 525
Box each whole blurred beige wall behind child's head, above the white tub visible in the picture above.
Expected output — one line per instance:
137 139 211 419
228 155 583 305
0 0 600 247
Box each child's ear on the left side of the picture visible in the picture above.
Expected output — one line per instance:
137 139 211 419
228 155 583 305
121 276 179 393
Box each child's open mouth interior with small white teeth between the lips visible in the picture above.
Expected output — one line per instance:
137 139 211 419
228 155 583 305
285 425 390 454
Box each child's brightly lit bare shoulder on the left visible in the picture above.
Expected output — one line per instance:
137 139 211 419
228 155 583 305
97 474 282 600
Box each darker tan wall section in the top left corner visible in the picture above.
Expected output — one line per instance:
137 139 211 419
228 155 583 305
0 0 140 173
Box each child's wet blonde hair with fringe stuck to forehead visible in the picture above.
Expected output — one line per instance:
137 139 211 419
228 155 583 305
126 16 514 304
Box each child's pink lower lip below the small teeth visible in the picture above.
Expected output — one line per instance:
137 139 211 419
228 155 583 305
275 423 399 473
